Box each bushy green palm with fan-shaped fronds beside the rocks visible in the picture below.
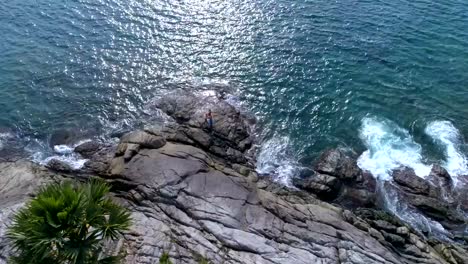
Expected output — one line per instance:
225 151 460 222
7 180 131 264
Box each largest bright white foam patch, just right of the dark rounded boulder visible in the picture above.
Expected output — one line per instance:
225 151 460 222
358 117 431 180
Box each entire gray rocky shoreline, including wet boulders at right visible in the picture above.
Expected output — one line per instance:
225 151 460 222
0 93 468 264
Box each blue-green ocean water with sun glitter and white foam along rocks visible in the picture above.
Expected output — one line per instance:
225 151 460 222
0 0 468 184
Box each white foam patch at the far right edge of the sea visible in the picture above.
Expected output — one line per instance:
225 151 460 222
425 121 468 180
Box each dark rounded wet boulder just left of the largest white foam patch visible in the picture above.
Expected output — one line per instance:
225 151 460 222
315 149 362 180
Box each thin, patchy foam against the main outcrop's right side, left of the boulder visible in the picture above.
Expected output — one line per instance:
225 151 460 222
257 137 300 186
